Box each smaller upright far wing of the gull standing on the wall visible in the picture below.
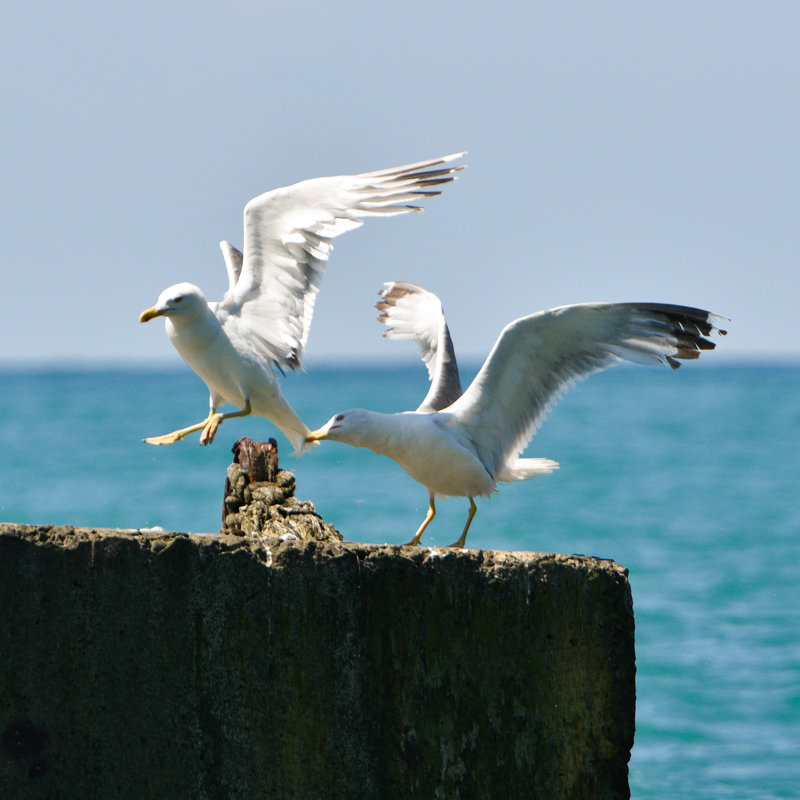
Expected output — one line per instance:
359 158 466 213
375 281 461 411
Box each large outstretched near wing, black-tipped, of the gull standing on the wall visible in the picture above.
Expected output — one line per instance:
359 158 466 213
447 303 725 476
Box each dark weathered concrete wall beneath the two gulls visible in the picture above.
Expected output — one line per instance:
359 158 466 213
0 525 634 800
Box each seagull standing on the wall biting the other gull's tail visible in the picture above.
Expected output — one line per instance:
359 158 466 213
307 292 726 548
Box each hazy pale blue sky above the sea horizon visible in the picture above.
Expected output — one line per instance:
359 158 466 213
0 0 800 363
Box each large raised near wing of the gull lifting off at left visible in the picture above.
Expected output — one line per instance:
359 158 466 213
217 153 464 369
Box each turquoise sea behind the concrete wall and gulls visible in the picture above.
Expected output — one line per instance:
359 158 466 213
0 364 800 800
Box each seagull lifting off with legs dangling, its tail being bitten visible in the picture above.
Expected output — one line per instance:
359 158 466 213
139 153 465 452
